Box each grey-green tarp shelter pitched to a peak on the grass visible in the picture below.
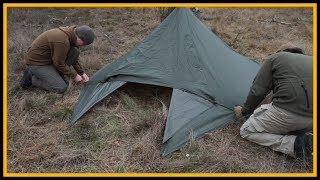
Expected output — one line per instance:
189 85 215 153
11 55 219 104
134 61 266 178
70 8 260 155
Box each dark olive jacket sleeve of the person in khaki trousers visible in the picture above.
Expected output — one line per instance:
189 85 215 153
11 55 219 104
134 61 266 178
242 58 272 116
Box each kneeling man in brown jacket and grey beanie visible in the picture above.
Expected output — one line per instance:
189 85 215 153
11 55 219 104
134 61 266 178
20 25 96 93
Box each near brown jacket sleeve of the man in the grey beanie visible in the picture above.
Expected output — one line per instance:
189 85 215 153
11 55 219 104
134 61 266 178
51 43 76 78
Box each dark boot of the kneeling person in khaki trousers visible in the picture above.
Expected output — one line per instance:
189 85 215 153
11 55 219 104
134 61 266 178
294 133 313 166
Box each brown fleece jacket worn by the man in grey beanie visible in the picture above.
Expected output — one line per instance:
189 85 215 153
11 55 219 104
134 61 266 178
25 26 83 78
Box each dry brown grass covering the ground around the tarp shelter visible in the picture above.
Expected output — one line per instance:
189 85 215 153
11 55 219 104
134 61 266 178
7 8 312 176
